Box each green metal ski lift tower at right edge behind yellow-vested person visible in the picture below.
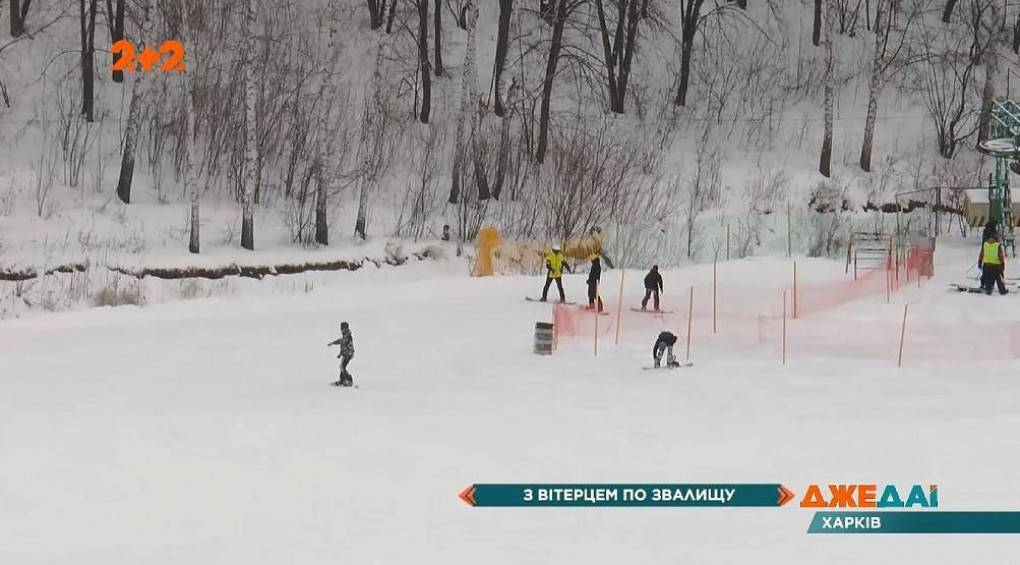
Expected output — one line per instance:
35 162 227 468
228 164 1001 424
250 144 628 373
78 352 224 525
972 99 1020 257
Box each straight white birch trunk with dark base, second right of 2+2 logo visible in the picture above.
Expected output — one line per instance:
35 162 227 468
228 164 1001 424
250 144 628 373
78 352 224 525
241 0 258 250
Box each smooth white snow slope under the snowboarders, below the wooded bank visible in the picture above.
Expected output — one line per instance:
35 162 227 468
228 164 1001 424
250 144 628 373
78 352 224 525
0 243 1020 565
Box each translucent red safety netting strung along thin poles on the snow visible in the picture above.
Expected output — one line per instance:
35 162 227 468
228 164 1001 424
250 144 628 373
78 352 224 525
553 246 1020 365
